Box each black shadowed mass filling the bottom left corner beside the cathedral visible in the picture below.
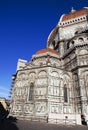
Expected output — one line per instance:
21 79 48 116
0 102 19 130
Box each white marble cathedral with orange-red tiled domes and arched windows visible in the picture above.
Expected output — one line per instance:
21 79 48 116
10 7 88 124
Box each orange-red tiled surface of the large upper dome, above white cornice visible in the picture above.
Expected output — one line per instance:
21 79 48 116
61 8 88 22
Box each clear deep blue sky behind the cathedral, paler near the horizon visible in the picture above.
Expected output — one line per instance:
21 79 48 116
0 0 88 98
